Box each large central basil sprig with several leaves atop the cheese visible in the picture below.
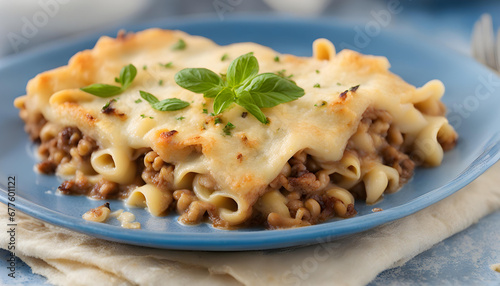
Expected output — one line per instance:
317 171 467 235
175 53 304 124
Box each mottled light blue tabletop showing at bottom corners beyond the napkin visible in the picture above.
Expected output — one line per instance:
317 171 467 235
0 212 500 286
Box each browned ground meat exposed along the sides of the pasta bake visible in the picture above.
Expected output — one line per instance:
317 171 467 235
26 108 451 228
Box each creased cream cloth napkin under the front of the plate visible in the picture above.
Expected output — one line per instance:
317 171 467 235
0 163 500 285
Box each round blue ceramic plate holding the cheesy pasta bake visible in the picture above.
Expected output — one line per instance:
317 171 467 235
0 17 500 251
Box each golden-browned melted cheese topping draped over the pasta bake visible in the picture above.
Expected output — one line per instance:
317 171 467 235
17 29 444 225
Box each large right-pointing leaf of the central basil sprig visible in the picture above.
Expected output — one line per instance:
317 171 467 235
244 73 305 108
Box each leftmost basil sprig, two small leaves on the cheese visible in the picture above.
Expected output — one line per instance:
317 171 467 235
80 64 137 98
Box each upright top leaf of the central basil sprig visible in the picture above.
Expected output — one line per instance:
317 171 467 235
226 53 259 87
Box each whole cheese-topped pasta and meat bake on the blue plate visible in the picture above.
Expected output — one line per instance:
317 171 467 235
15 29 457 228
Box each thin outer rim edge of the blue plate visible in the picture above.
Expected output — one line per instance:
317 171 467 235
0 15 500 251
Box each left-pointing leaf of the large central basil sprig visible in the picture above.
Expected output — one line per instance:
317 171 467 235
174 68 224 94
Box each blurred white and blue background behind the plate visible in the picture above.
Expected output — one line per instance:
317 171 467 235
0 0 500 57
